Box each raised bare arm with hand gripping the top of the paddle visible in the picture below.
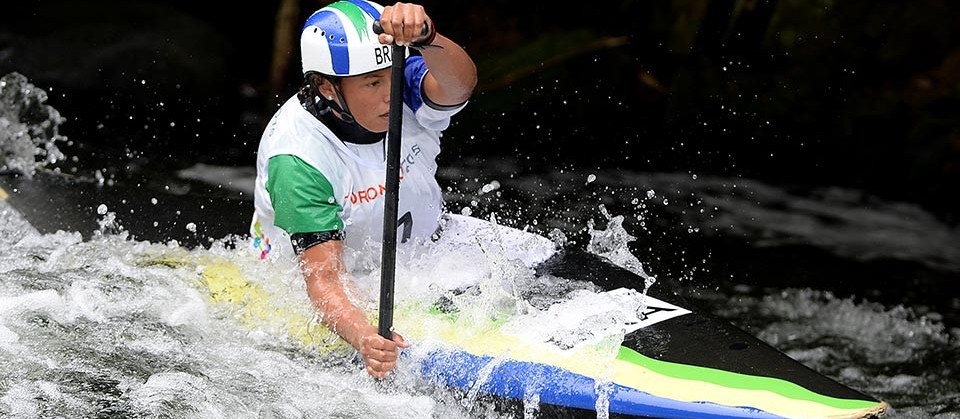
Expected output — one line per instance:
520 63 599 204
380 3 477 106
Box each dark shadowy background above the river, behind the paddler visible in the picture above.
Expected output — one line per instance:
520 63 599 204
0 0 960 225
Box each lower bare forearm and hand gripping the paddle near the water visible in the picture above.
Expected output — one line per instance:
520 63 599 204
300 240 408 378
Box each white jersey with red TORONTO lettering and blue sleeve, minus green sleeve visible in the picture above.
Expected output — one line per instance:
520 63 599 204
251 56 463 257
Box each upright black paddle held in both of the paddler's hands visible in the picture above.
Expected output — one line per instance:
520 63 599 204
373 21 429 340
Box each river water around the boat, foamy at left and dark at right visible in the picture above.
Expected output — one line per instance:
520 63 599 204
0 72 960 418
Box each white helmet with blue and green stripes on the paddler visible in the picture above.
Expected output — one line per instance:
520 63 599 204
300 0 390 77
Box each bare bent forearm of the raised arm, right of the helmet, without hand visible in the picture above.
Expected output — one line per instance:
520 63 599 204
423 34 477 105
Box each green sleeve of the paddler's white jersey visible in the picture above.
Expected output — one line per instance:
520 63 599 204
266 154 343 237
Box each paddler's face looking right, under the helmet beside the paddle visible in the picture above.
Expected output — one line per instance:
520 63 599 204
340 68 391 132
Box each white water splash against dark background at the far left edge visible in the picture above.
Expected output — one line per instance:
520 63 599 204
0 73 66 177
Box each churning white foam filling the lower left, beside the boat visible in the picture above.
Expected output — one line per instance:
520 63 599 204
0 203 512 418
